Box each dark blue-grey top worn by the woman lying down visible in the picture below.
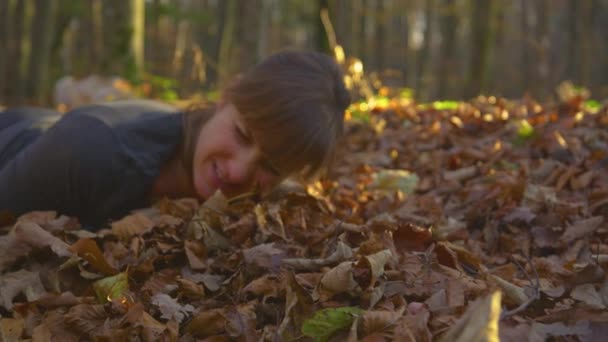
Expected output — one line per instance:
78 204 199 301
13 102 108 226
0 100 183 226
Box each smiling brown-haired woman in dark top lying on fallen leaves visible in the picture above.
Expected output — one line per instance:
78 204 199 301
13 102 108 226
0 52 349 226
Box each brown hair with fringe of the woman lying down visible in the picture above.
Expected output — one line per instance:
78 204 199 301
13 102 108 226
184 51 350 179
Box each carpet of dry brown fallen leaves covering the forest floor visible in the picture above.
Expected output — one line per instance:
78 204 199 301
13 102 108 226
0 93 608 341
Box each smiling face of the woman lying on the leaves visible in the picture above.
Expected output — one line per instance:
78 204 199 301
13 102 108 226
192 103 284 198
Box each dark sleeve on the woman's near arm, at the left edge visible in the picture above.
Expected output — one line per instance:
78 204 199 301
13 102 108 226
0 114 126 226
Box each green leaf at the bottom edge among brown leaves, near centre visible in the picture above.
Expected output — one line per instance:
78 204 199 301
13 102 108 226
302 306 365 342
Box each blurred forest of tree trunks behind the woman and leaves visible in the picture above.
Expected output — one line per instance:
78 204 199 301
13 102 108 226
0 0 608 106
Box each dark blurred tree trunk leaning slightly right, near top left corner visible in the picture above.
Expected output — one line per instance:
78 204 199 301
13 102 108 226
26 0 57 104
